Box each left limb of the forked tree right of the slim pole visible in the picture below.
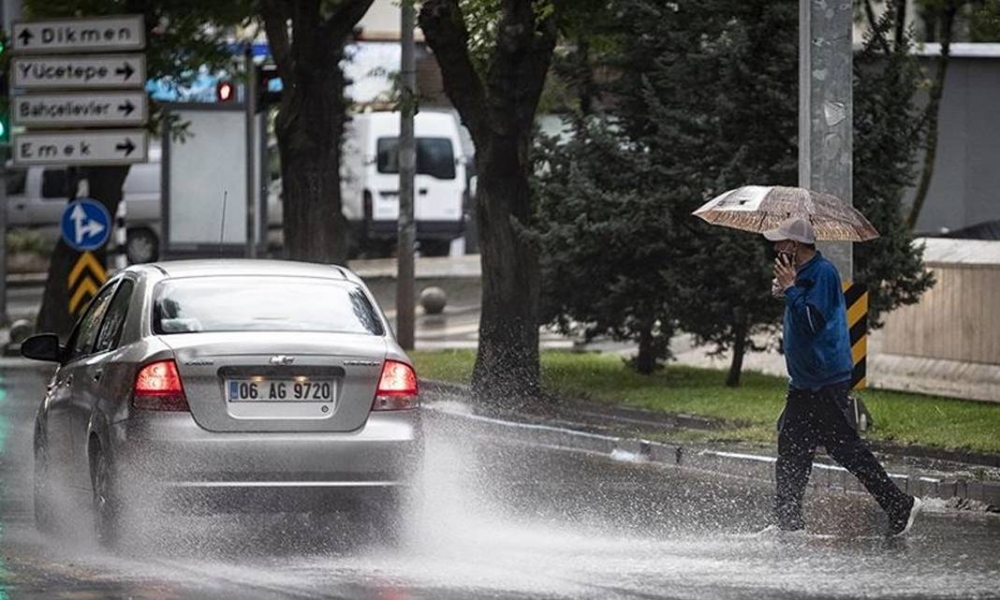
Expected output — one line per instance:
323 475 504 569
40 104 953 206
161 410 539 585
418 0 486 143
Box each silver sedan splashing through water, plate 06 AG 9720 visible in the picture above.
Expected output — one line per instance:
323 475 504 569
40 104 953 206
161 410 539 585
21 260 422 544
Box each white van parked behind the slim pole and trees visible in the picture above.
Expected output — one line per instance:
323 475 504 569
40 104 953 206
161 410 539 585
341 111 468 256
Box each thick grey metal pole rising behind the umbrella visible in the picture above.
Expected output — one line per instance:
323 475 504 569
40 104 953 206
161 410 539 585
799 0 854 281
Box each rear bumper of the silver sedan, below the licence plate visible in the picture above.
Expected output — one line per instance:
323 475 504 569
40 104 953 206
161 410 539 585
111 410 423 511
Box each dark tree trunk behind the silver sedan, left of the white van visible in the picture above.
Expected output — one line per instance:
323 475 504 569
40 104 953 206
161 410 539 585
275 55 347 264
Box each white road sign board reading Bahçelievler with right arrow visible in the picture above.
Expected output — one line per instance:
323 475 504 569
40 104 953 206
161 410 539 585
11 90 149 127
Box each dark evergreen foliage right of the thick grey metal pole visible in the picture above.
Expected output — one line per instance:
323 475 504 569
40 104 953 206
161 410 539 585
853 3 934 328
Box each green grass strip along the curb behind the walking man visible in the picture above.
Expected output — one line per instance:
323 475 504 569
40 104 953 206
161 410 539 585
411 350 1000 453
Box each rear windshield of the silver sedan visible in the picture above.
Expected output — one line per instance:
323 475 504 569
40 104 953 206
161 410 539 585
153 276 384 335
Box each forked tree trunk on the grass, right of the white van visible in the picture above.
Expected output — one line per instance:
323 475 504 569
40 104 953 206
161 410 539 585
419 0 556 405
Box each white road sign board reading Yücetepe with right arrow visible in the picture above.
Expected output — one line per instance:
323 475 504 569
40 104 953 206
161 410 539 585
11 54 146 90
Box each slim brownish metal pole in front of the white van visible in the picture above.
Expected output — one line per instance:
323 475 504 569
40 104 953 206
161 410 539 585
396 0 417 350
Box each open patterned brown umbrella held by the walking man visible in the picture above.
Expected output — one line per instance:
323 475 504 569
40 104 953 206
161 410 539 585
692 185 879 242
